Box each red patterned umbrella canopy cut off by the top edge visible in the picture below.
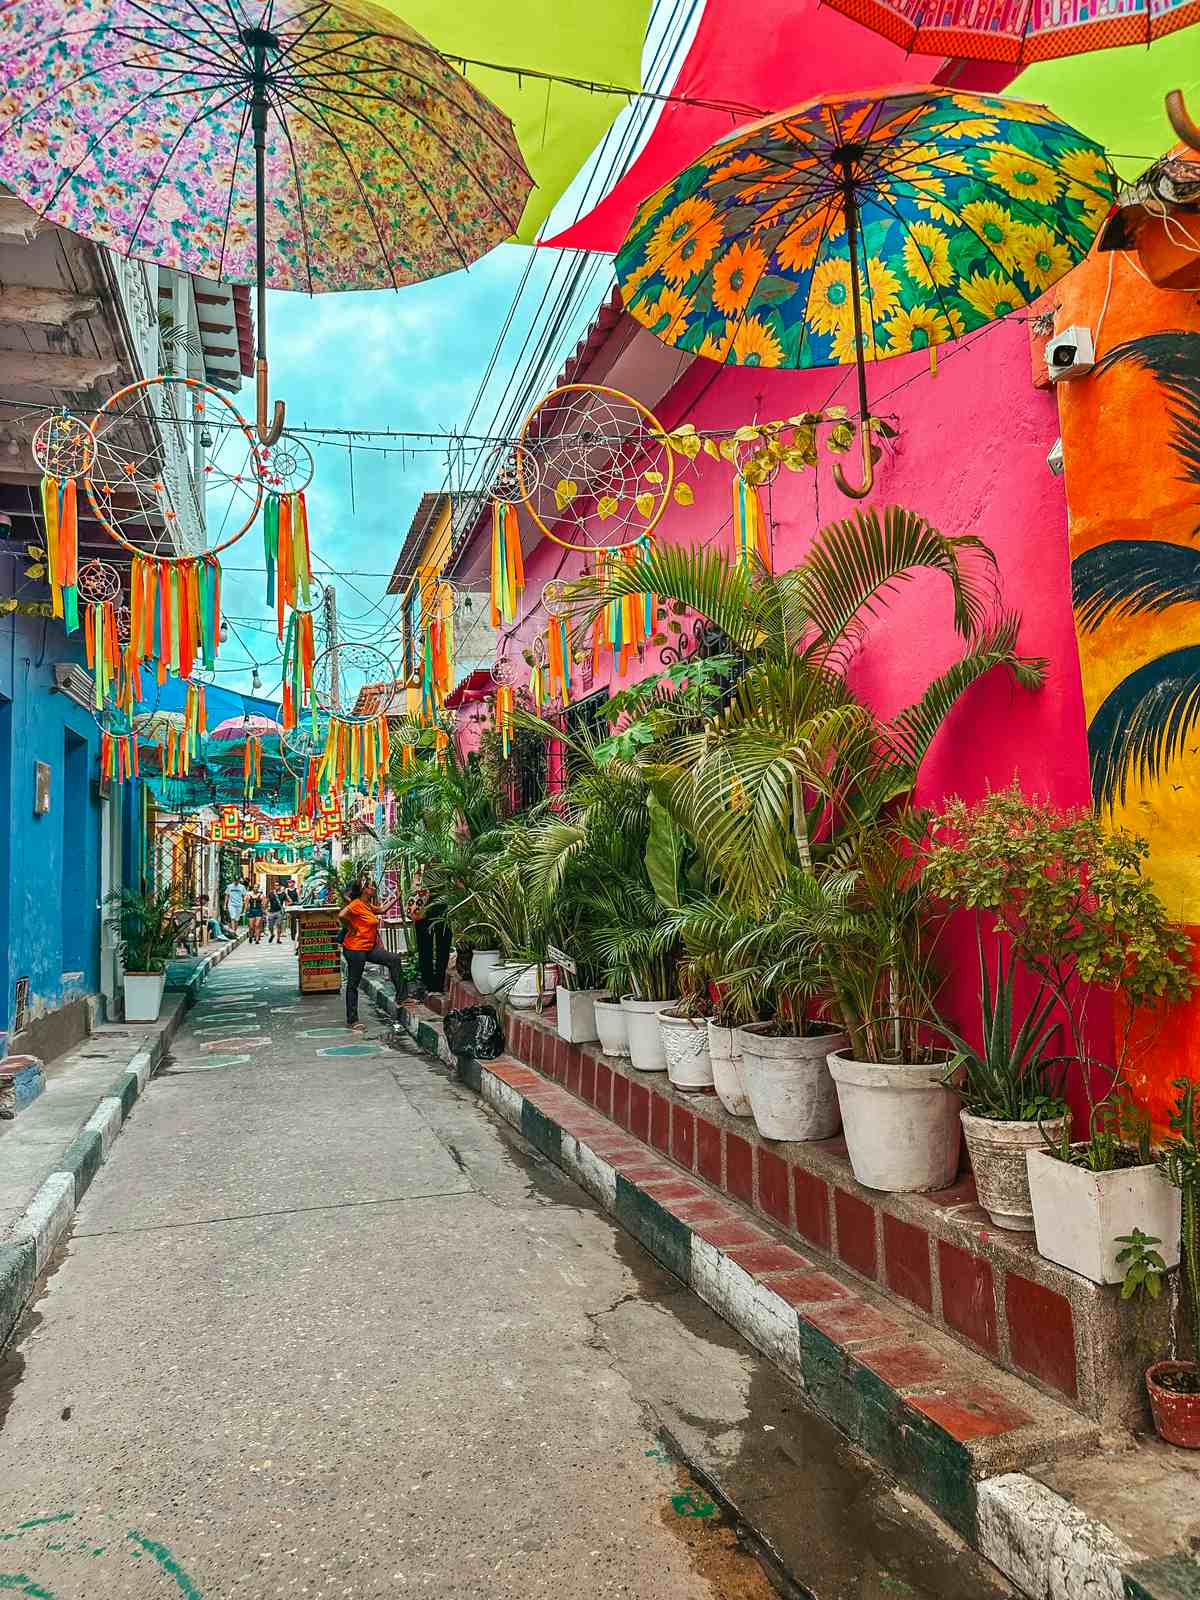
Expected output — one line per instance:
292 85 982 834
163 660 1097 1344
812 0 1200 66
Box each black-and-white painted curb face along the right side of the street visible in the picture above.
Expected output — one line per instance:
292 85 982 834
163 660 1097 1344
387 979 1200 1600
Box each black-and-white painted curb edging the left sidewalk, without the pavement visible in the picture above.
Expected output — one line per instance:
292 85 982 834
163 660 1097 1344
0 934 246 1349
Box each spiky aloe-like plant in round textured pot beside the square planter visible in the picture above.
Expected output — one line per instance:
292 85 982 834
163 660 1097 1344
942 925 1067 1234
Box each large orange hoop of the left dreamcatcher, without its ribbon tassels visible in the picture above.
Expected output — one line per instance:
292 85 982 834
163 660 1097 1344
83 374 262 565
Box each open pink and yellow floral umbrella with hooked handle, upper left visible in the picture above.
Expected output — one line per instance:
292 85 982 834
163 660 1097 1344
0 0 531 443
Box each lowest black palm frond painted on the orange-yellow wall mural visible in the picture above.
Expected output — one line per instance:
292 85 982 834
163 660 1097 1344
1088 645 1200 808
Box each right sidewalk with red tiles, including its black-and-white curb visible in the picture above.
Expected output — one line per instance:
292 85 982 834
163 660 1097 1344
377 978 1200 1600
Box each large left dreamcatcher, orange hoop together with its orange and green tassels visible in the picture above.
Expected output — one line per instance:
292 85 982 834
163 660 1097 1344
83 376 262 682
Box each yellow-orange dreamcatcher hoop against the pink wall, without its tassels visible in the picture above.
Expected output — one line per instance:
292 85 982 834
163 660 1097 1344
517 384 675 555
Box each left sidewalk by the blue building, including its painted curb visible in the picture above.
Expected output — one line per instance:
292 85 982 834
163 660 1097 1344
0 936 242 1344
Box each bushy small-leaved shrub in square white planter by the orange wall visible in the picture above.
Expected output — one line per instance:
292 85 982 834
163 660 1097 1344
925 784 1197 1283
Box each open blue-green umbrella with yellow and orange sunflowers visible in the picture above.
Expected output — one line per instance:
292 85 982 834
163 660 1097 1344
616 86 1114 493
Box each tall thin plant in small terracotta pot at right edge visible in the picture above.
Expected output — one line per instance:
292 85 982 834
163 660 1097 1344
1146 1078 1200 1450
